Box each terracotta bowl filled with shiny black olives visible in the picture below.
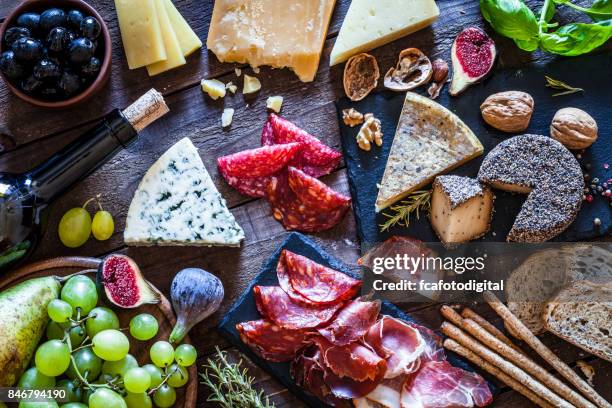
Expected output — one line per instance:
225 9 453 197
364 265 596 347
0 0 111 109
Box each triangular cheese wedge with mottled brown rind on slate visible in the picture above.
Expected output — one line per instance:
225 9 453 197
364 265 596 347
376 92 483 212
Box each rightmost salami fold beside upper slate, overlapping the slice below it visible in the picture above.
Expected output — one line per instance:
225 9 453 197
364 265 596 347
288 166 351 211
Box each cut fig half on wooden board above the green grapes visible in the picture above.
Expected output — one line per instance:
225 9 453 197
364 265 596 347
97 254 160 309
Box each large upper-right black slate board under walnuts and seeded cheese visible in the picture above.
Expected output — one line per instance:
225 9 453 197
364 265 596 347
336 53 612 243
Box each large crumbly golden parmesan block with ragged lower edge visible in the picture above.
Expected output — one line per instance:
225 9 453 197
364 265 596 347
206 0 335 82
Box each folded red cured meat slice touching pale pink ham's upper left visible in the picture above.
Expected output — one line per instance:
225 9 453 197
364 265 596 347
318 300 380 346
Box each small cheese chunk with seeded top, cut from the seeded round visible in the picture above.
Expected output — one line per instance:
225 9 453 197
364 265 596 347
429 176 494 245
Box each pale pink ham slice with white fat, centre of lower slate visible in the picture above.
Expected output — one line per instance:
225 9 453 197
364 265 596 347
364 316 427 378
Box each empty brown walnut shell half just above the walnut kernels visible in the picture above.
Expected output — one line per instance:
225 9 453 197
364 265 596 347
343 53 380 101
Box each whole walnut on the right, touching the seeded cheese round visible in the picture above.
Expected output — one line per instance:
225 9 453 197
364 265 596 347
550 108 597 150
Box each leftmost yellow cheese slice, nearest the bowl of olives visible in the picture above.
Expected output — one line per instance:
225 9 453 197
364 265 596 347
115 0 166 69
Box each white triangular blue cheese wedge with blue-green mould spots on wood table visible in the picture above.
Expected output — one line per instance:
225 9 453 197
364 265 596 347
123 138 244 246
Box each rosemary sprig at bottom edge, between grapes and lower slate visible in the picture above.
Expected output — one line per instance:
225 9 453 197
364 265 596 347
200 347 274 408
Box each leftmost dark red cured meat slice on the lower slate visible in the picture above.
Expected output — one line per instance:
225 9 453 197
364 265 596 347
236 319 307 362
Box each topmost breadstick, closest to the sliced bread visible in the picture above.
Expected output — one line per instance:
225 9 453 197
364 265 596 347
483 291 612 408
